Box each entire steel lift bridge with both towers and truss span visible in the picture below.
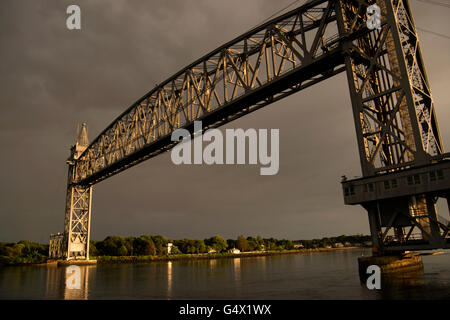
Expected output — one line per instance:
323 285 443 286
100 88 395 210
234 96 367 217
50 0 450 260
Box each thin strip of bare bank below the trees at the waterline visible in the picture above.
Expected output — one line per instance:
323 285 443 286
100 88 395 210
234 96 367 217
91 247 362 264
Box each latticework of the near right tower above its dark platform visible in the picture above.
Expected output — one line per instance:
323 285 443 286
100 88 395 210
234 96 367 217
337 0 443 176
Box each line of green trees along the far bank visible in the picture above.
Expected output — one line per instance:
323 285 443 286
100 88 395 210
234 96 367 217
0 235 371 264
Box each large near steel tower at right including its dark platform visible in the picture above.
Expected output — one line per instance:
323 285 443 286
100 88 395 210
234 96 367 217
337 0 450 254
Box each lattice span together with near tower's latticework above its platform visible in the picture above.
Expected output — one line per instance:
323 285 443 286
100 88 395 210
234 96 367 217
73 0 443 184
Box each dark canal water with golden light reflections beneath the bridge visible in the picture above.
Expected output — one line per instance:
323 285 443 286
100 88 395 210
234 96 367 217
0 249 450 300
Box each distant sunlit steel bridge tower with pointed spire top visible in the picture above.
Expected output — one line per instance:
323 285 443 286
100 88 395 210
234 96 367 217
61 123 92 260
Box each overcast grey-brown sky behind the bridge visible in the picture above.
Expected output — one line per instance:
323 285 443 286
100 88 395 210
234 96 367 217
0 0 450 243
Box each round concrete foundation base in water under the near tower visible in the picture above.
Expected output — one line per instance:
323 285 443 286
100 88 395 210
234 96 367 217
358 254 423 282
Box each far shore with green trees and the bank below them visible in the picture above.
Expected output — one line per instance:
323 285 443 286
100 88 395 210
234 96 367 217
0 234 371 267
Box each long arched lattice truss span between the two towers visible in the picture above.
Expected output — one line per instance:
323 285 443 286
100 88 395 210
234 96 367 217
74 0 352 185
